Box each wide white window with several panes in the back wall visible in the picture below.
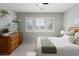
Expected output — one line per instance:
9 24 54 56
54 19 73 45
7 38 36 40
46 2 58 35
25 18 54 32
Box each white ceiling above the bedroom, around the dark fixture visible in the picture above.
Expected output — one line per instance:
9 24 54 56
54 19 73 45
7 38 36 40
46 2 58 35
0 3 77 13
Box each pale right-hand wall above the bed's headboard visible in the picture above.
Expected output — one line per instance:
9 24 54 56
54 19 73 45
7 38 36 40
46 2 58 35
64 4 79 30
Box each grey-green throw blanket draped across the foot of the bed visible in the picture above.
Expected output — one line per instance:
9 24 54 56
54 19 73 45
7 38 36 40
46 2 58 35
41 39 57 54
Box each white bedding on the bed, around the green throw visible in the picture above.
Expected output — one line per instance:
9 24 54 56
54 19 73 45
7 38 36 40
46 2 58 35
37 37 79 56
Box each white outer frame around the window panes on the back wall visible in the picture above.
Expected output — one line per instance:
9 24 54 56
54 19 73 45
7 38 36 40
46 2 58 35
25 17 55 32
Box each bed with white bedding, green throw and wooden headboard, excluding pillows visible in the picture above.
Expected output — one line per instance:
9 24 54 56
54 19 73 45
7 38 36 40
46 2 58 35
37 27 79 56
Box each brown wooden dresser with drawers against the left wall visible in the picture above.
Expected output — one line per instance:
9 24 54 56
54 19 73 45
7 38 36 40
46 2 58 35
0 32 22 55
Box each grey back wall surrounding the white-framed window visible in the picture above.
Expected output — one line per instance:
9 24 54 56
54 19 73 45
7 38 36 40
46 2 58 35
18 13 63 42
